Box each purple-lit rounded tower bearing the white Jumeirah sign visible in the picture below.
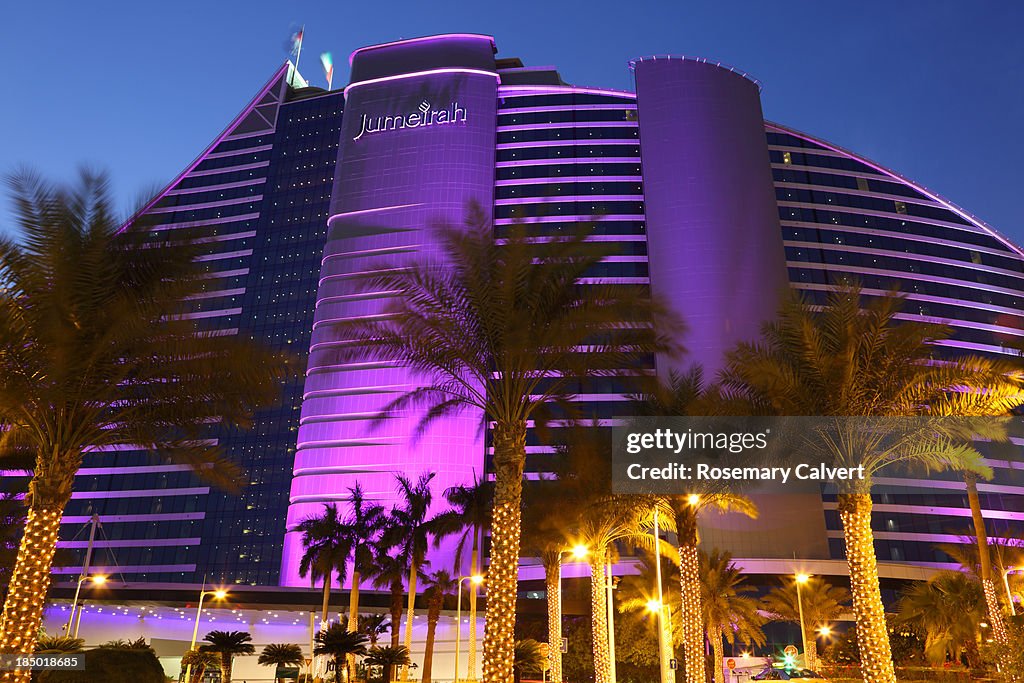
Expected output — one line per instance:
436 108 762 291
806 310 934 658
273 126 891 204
282 35 498 586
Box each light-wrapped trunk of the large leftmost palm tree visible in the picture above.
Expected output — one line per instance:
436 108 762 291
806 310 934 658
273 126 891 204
0 497 70 683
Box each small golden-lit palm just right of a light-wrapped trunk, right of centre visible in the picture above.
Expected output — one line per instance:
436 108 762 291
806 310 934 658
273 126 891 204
700 548 766 683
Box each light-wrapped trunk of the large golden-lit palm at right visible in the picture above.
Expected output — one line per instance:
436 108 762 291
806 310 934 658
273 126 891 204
839 494 896 683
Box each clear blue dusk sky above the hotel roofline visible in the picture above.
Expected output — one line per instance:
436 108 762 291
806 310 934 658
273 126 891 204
0 0 1024 244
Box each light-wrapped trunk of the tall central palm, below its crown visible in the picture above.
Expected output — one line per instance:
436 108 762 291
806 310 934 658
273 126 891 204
483 420 526 683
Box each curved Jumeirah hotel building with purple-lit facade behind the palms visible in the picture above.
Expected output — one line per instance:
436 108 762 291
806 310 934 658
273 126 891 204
34 34 1024 588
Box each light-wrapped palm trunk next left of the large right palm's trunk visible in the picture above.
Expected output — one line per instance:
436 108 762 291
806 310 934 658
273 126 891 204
676 508 707 683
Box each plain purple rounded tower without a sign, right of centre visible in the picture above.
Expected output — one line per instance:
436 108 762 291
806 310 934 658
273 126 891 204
631 56 787 379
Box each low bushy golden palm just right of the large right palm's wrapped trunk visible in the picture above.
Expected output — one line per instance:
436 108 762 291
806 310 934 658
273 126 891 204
896 571 985 668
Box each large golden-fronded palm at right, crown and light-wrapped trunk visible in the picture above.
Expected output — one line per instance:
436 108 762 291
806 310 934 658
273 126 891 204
721 287 1015 683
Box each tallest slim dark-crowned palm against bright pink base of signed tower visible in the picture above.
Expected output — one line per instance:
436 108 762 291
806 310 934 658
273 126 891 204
381 472 436 681
